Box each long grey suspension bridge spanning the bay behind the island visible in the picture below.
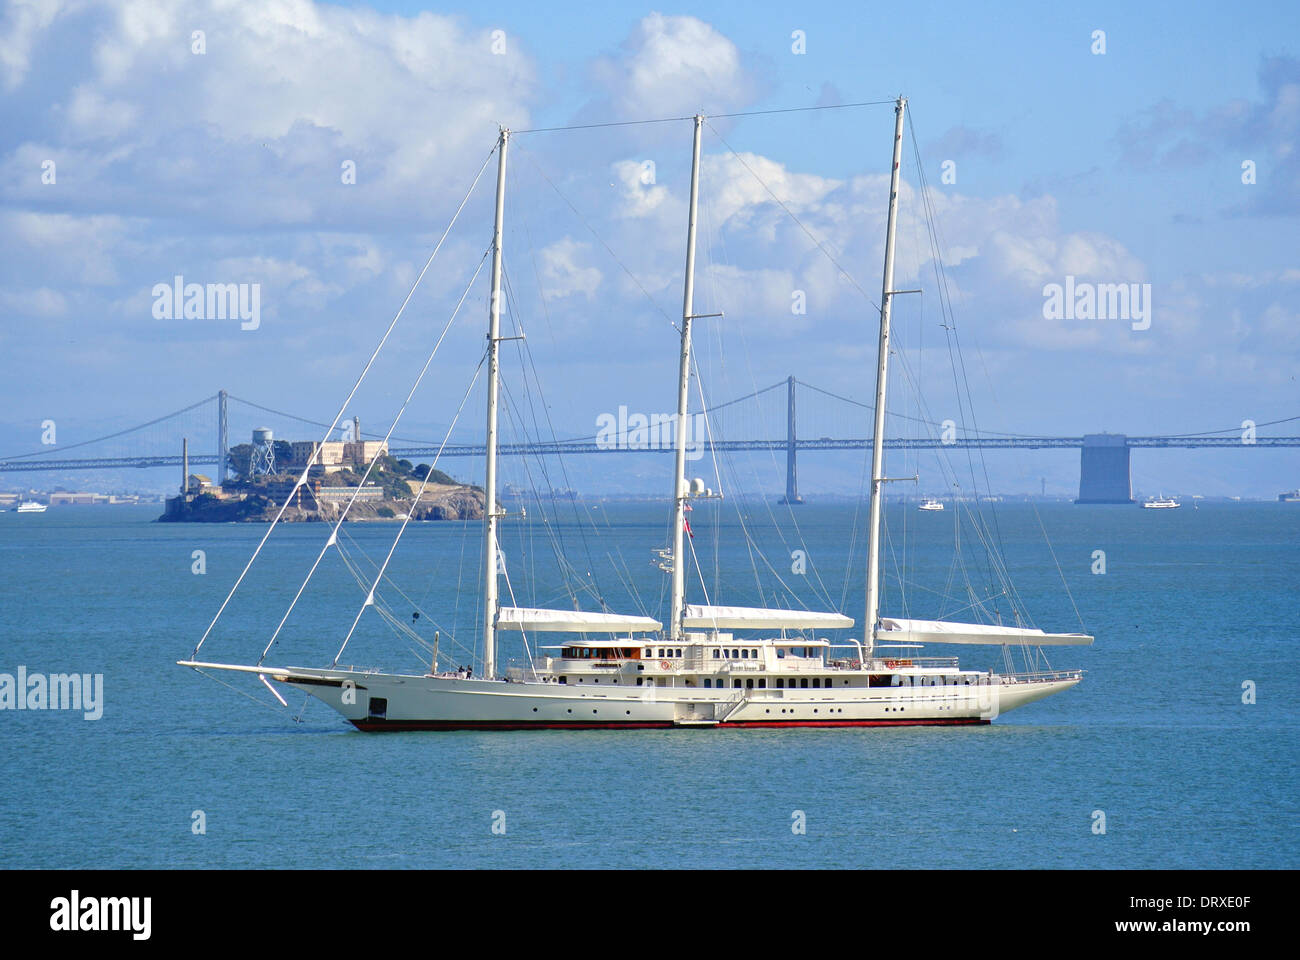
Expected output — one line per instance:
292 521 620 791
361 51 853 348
0 376 1300 503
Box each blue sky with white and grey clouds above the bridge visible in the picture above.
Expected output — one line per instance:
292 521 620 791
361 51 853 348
0 0 1300 497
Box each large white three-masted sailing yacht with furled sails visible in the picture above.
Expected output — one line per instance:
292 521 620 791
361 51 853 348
178 98 1092 731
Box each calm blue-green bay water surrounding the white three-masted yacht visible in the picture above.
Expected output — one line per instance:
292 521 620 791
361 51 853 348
0 502 1300 868
